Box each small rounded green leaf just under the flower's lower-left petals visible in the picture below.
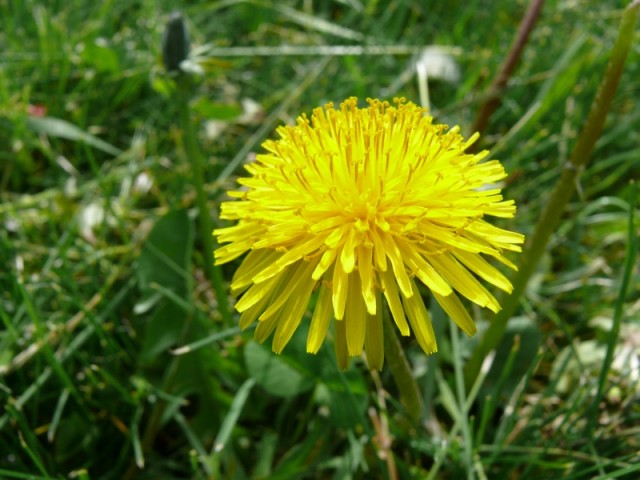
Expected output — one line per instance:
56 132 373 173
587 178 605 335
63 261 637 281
244 341 314 398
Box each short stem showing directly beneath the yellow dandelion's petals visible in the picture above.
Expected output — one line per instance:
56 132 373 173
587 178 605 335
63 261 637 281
383 315 423 422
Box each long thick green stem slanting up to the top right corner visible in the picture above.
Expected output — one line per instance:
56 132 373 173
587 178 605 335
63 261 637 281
465 0 640 386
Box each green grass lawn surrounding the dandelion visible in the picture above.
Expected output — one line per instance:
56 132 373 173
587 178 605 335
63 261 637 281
0 0 640 480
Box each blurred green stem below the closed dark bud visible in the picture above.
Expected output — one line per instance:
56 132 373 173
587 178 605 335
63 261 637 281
177 74 232 326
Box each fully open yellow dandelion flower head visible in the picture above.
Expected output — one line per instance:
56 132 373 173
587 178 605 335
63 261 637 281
214 98 524 369
